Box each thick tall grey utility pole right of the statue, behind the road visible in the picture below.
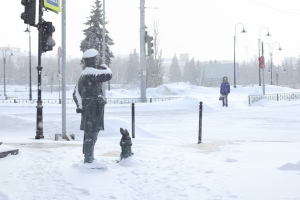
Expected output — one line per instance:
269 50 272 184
140 0 147 102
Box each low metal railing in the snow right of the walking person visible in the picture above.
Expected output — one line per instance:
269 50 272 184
249 92 300 105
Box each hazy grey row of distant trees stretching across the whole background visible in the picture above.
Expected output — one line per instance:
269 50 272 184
0 50 300 88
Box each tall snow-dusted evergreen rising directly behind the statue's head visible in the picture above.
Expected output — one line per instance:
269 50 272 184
80 0 114 66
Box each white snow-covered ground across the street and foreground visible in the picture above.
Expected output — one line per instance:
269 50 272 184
0 83 300 200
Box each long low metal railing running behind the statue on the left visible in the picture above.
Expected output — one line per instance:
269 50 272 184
0 97 182 104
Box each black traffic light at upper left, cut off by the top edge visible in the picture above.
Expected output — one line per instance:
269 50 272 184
21 0 36 26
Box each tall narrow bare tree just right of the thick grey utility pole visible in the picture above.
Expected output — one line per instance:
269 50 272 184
146 20 165 87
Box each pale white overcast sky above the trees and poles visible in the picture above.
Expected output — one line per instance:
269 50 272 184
0 0 300 64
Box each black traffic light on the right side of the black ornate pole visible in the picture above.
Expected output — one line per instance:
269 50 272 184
41 21 55 53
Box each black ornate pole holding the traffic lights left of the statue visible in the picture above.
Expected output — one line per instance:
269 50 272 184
35 0 44 139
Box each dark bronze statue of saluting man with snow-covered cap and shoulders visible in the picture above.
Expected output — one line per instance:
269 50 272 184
73 49 112 163
